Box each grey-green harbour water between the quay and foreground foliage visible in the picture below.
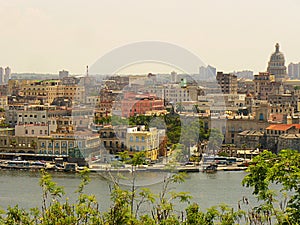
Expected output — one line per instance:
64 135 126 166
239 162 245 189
0 170 255 210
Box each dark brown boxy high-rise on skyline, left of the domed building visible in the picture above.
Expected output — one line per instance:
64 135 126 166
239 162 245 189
216 72 238 94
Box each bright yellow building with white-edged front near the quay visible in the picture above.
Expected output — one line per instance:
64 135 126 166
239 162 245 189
126 126 159 160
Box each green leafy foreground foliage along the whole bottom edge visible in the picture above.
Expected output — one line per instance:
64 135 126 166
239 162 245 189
0 150 300 225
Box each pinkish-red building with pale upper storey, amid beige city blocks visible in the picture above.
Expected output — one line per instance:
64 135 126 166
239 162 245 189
121 92 164 117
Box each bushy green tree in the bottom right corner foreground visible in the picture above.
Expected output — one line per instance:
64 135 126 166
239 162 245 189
243 150 300 224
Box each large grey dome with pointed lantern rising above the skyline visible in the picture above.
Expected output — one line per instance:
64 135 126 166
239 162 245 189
267 43 288 82
